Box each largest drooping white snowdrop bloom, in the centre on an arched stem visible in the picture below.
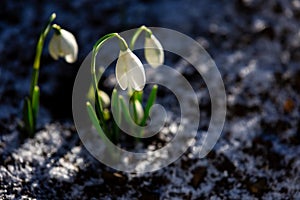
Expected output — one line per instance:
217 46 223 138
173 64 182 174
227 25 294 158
116 48 146 91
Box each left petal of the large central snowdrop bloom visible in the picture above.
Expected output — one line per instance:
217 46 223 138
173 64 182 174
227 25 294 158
116 51 128 90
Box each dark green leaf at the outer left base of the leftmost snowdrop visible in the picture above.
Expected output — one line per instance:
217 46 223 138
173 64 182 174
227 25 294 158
23 97 35 137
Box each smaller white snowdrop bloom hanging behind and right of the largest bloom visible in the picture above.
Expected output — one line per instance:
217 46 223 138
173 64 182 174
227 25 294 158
145 34 164 68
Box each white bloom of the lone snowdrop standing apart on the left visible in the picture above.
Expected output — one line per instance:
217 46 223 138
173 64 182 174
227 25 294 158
48 29 78 63
